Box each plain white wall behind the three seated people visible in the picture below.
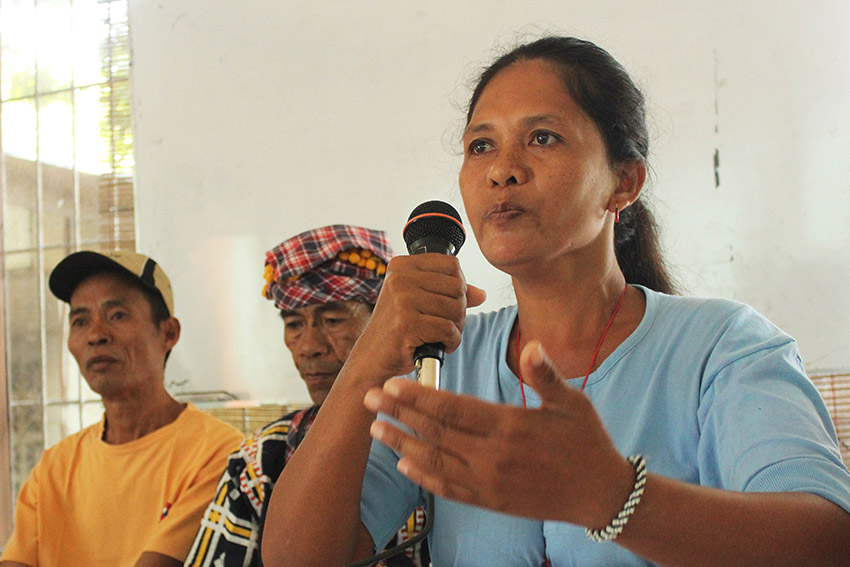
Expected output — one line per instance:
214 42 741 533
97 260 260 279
130 0 850 402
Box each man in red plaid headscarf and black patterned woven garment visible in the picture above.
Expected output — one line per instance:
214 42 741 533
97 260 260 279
185 225 429 567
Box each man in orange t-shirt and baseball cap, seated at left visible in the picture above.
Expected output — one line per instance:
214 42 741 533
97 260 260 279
0 251 242 567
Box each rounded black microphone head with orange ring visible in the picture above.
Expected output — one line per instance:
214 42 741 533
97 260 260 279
402 201 466 256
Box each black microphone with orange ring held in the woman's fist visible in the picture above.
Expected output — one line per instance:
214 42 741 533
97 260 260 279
402 201 466 390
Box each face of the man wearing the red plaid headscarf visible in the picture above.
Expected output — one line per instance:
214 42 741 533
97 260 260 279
280 301 372 405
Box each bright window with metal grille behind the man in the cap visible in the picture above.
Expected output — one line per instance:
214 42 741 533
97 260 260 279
0 0 135 541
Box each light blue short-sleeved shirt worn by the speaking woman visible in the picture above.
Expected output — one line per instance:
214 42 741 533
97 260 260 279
361 287 850 567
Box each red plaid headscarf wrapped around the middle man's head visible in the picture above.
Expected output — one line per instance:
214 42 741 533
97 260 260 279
263 224 393 309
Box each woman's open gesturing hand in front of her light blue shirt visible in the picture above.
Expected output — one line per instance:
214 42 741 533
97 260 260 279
364 341 634 528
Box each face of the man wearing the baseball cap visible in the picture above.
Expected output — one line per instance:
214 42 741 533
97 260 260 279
68 273 180 400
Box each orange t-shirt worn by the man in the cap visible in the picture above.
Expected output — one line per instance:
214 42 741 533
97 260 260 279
0 404 242 567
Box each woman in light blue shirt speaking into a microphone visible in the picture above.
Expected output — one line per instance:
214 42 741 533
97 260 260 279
263 37 850 567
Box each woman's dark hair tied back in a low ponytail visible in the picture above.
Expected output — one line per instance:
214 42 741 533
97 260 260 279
466 37 676 293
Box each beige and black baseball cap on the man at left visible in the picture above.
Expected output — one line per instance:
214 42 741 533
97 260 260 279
48 250 174 315
